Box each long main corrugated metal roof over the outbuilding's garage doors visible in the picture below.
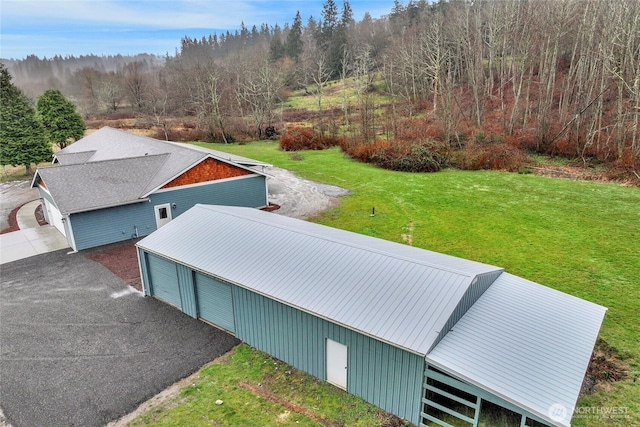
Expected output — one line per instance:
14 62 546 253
138 205 500 356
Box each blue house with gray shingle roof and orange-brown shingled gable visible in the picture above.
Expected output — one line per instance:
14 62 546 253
31 127 270 250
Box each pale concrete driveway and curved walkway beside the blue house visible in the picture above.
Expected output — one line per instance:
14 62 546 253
0 200 69 264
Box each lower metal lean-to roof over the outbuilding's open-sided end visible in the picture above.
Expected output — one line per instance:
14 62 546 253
427 273 606 426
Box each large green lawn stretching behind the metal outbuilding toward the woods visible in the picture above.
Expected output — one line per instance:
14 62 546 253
189 142 640 426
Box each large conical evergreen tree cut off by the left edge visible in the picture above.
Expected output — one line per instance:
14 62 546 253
0 63 53 174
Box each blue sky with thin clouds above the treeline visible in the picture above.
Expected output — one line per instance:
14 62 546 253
0 0 393 59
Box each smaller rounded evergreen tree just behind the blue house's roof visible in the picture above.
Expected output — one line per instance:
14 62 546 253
36 89 87 149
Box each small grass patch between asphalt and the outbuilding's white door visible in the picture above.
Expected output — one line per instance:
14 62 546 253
127 344 398 427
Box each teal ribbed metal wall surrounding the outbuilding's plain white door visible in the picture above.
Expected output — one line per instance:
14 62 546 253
233 286 424 425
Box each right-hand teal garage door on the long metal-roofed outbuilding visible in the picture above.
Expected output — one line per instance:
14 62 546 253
196 273 235 332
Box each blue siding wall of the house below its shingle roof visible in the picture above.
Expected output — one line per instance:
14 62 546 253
70 175 267 250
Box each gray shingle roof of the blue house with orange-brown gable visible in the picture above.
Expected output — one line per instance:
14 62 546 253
32 127 269 214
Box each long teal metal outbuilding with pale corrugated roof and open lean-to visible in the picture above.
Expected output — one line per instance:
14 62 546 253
137 205 606 427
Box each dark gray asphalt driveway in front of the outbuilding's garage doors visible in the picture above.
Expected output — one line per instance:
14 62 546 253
0 250 238 427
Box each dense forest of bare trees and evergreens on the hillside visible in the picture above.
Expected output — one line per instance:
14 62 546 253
4 0 640 179
